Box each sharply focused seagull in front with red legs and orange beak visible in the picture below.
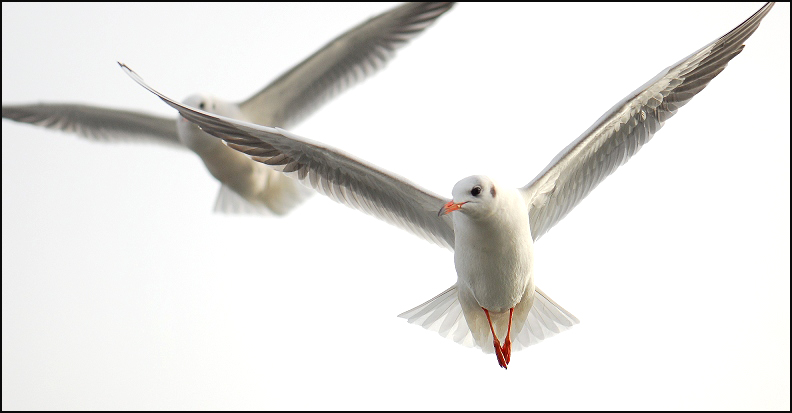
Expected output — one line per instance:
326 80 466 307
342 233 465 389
119 3 773 368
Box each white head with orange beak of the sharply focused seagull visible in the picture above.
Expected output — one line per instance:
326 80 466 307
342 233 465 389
438 175 499 218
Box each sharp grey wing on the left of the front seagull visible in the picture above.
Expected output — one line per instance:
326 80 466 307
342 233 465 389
124 63 454 249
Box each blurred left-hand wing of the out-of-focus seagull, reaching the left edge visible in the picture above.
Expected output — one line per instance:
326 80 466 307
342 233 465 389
3 103 183 147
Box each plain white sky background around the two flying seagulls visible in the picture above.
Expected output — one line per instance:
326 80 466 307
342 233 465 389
2 3 790 410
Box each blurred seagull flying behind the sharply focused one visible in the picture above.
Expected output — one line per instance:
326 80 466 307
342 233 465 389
3 3 453 215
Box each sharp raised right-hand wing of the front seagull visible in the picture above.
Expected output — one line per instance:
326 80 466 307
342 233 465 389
521 3 773 240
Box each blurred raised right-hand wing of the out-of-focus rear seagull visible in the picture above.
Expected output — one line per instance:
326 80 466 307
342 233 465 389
240 3 453 128
